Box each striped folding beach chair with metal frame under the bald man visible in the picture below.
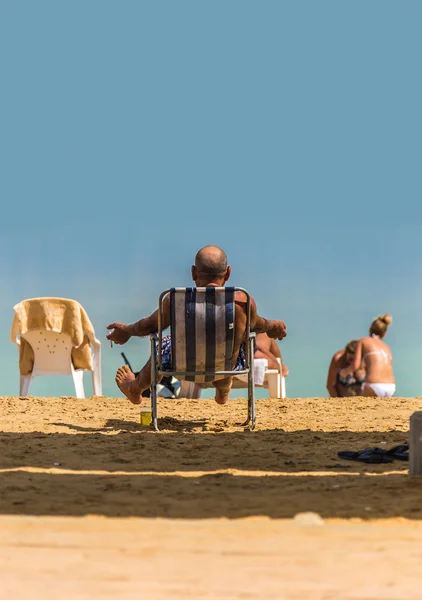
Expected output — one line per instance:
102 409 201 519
150 287 256 431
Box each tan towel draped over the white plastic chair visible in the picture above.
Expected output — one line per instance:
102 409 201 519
10 298 95 375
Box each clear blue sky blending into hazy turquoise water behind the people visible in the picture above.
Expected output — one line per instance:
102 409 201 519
0 0 422 397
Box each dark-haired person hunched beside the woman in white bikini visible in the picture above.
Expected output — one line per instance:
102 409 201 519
327 340 365 398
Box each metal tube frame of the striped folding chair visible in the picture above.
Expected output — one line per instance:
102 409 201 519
150 287 256 431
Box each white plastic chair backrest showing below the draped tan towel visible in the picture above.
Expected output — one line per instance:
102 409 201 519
22 329 73 377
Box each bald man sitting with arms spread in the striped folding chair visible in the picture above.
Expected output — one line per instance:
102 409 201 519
107 246 286 404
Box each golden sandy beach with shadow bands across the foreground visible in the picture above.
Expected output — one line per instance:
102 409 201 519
0 397 422 599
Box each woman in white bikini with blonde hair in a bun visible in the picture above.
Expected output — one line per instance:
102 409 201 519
353 315 396 398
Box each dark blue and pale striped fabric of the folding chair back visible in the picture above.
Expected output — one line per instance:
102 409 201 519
170 287 235 382
